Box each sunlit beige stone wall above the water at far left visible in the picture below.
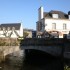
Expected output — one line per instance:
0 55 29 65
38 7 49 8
0 46 19 60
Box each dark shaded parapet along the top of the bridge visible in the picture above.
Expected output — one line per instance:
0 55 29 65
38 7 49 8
20 38 65 46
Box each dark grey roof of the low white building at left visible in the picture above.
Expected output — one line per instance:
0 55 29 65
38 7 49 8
0 23 21 30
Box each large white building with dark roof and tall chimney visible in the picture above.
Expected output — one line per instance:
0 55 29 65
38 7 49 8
36 7 70 38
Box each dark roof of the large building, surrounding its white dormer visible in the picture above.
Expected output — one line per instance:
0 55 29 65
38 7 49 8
44 10 68 19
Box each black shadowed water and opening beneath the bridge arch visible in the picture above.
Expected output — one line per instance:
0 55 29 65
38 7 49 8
21 50 62 70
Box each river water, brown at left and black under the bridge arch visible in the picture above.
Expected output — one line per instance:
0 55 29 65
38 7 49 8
0 50 68 70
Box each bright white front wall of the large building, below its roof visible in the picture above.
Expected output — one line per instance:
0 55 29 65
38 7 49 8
45 18 70 34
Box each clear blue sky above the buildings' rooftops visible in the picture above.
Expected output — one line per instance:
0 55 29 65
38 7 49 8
0 0 70 30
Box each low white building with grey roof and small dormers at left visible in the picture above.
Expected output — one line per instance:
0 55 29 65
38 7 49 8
0 23 23 38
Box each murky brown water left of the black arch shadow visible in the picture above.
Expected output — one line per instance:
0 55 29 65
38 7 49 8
0 51 23 70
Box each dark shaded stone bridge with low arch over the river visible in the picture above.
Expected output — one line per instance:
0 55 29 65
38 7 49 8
20 38 70 58
